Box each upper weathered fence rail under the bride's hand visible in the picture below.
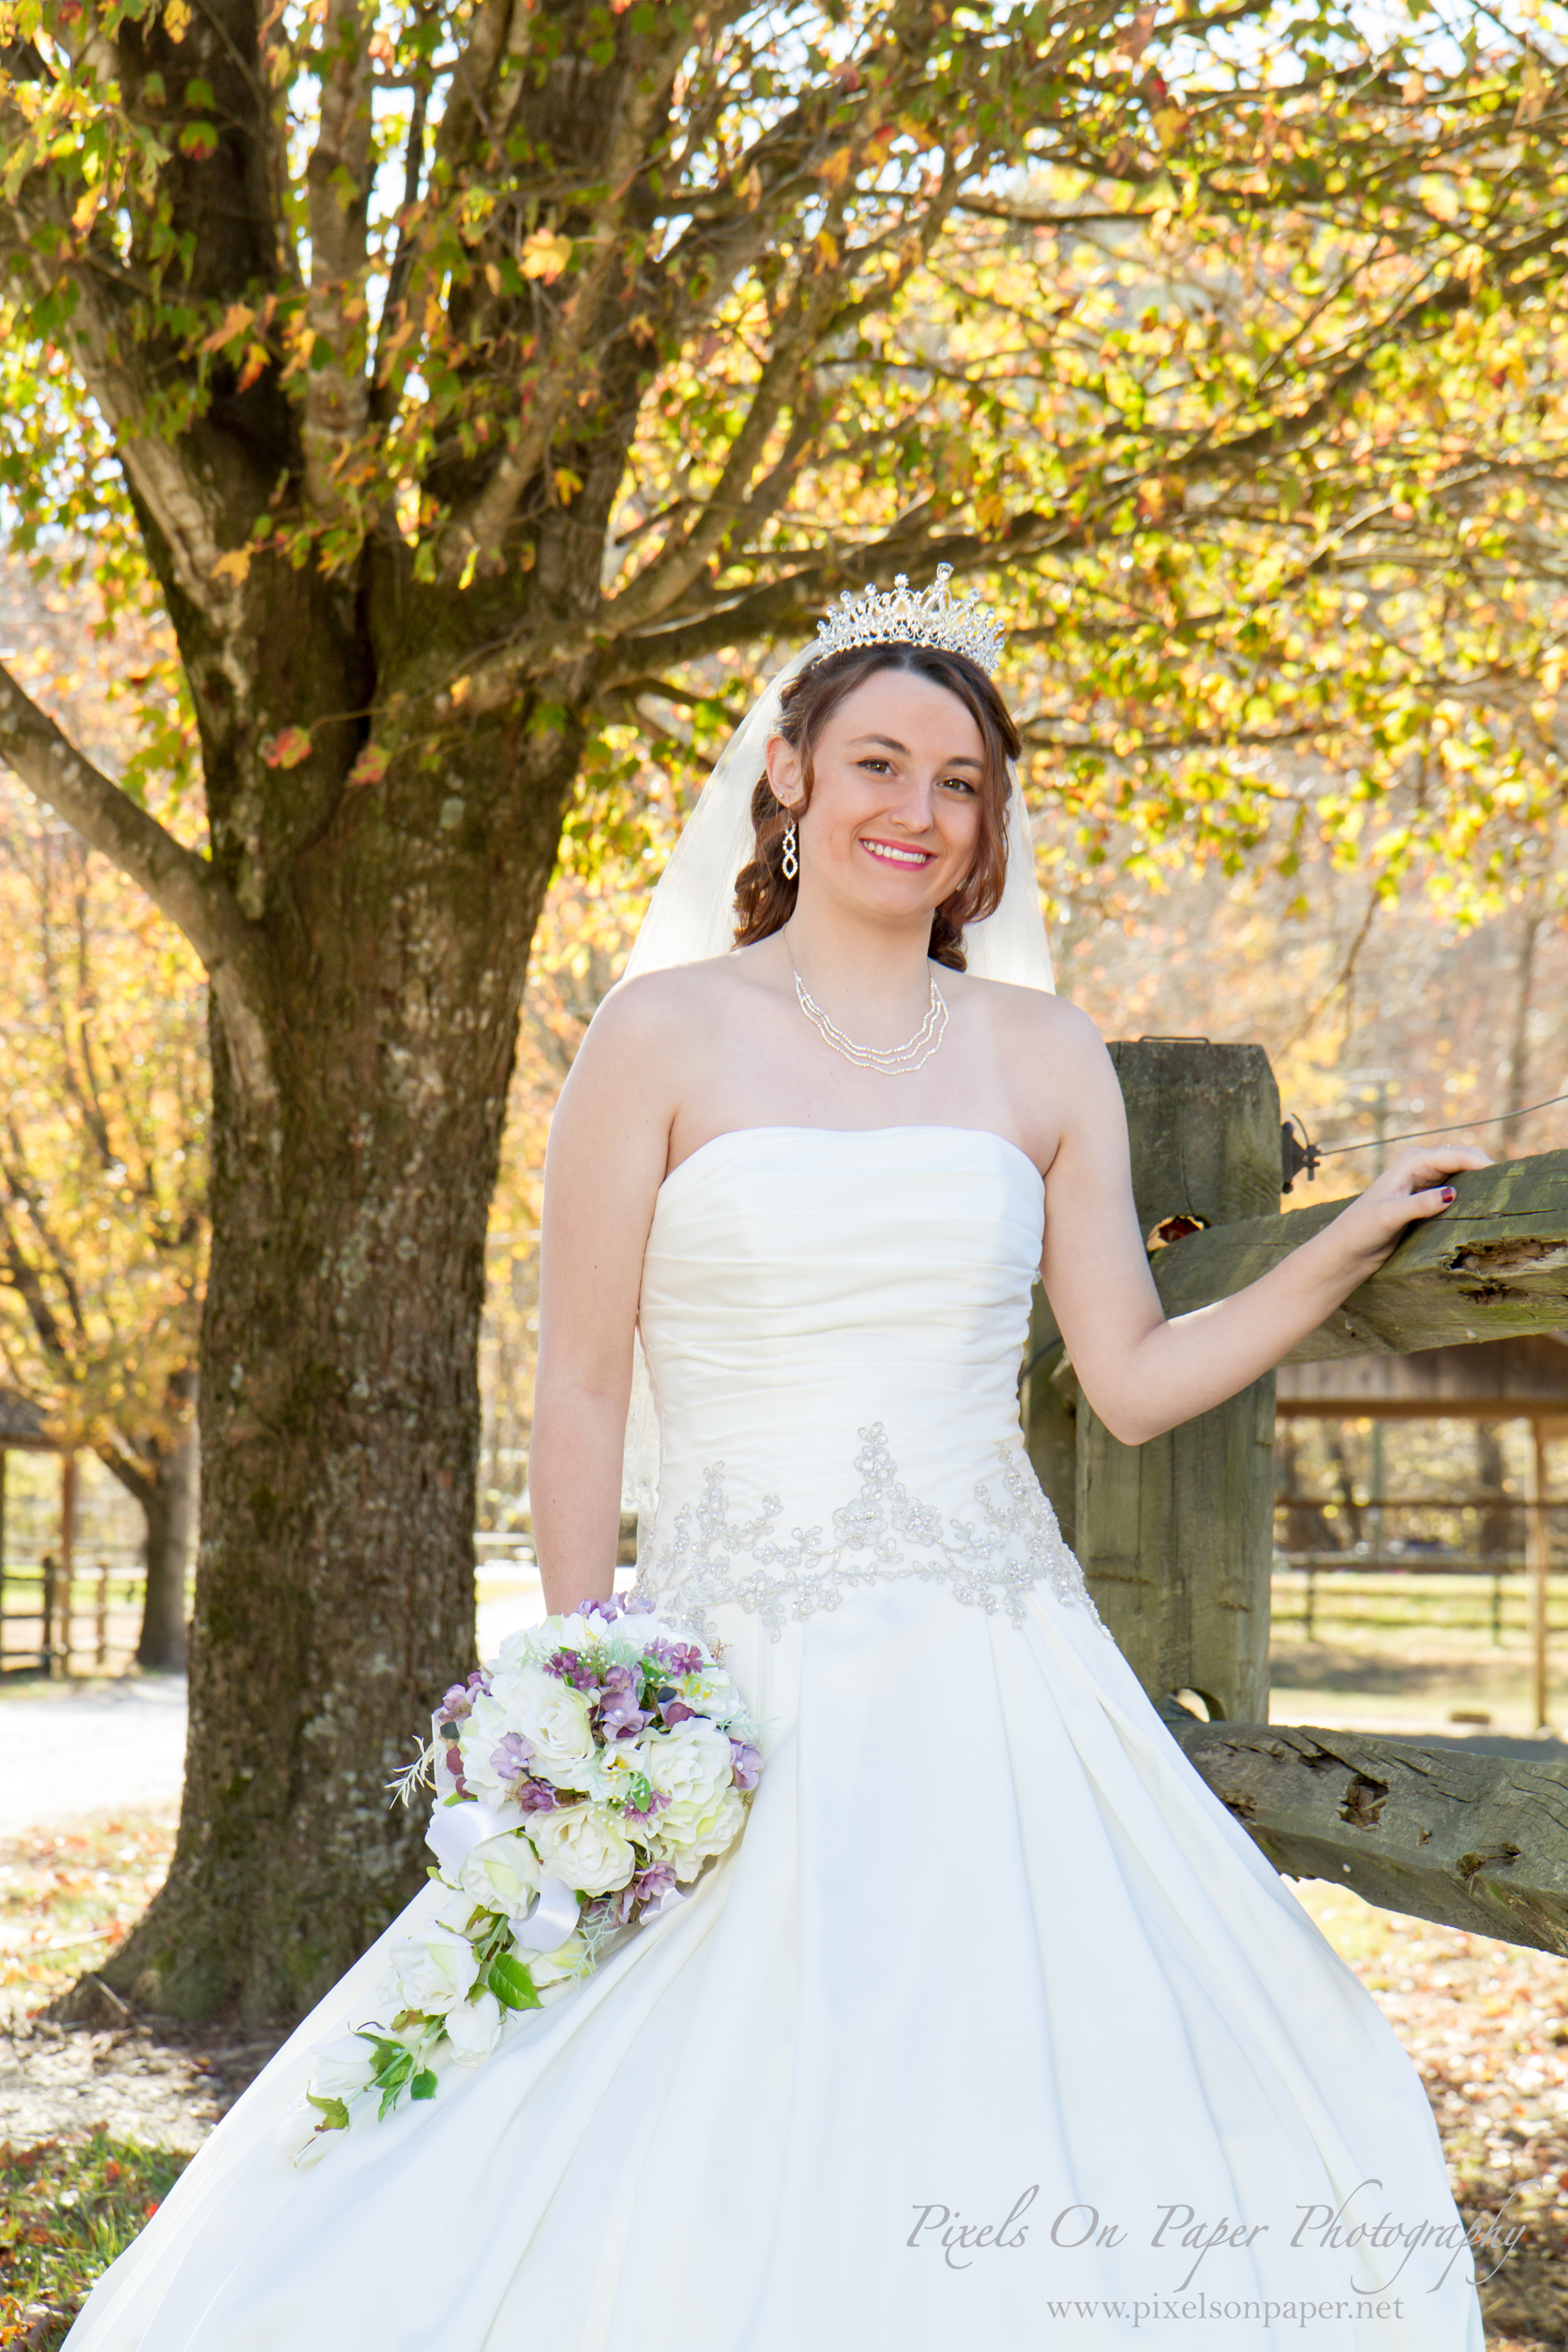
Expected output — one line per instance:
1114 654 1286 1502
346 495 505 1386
1152 1152 1568 1364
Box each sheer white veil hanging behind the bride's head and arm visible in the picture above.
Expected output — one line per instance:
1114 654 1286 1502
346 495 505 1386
621 645 1056 1505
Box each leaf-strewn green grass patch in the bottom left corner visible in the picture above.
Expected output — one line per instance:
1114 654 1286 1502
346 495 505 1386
0 2131 188 2352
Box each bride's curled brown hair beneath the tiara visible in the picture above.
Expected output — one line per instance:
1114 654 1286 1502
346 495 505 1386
736 642 1021 972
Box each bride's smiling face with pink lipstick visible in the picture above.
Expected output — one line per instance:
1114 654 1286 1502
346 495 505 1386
769 671 985 915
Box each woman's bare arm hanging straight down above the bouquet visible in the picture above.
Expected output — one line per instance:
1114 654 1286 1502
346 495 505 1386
529 981 672 1611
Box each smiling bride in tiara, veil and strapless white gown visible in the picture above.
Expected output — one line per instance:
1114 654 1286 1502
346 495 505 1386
70 581 1483 2352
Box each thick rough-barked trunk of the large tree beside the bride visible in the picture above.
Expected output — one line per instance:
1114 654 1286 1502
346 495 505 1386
101 717 578 2018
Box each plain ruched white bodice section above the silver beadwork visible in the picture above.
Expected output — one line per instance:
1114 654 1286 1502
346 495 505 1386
639 1126 1044 1494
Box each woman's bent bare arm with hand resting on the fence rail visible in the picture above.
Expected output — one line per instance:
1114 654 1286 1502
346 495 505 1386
1037 1007 1488 1446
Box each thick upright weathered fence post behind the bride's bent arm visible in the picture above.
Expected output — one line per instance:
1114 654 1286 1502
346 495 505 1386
1076 1037 1281 1724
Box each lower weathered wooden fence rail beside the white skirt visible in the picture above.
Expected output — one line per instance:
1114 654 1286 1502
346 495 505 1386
1166 1721 1568 1955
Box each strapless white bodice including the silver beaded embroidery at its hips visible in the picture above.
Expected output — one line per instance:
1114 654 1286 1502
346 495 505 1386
620 1126 1081 1625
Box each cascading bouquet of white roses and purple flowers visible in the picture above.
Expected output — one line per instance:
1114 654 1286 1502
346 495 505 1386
294 1599 762 2159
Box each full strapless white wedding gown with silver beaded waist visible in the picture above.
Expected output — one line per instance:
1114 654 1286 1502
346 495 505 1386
70 1126 1483 2352
